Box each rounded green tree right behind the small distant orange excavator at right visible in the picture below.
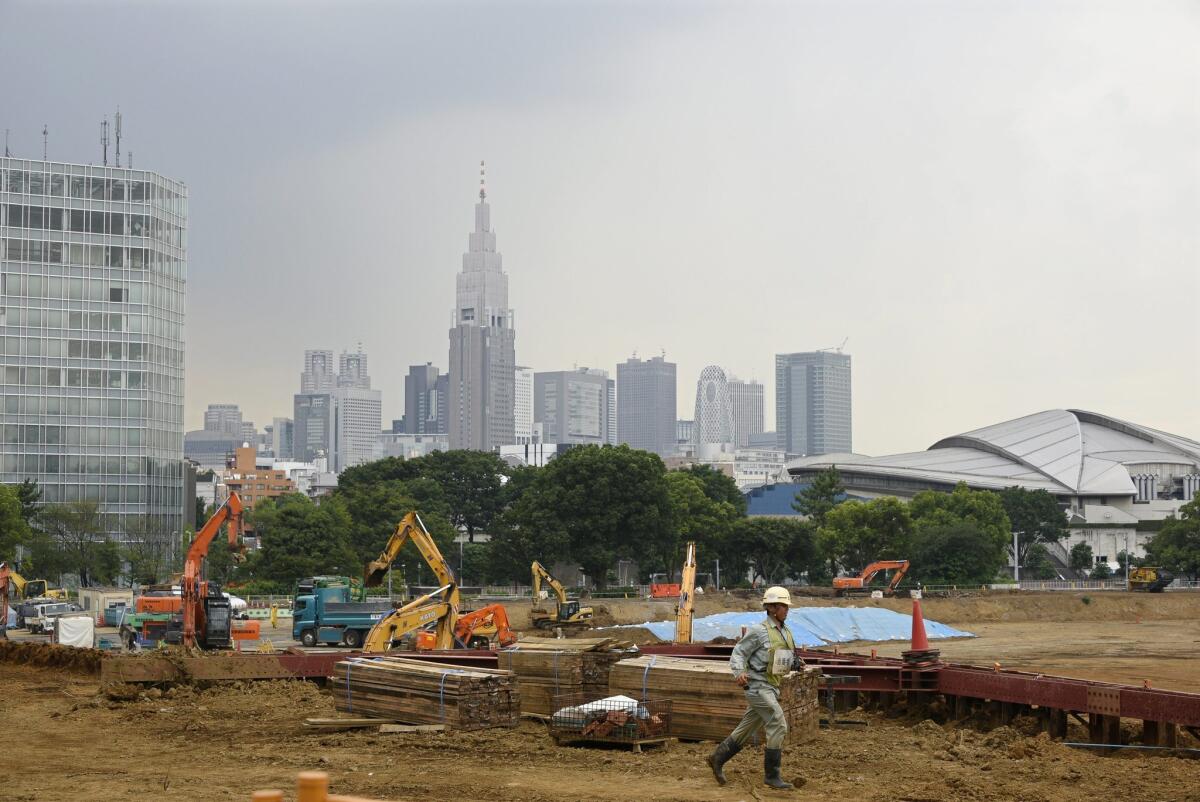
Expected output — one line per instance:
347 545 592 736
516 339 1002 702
817 496 913 570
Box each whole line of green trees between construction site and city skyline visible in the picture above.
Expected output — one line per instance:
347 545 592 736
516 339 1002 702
0 445 1200 593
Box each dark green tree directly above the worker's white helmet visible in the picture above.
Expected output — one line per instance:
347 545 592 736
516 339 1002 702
721 516 823 583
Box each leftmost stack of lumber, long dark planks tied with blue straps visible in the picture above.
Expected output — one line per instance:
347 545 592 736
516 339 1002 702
330 657 521 730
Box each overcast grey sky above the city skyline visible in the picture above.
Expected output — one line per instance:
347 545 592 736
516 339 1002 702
0 0 1200 454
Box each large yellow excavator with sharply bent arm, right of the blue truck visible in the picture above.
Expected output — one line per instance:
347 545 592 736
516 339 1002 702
362 511 461 653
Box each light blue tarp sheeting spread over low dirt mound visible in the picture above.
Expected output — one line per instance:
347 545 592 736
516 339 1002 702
635 608 974 646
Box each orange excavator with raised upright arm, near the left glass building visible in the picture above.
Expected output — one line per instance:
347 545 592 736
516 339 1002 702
179 492 244 648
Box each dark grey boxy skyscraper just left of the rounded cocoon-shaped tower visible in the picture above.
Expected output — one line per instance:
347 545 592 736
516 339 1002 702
617 357 676 456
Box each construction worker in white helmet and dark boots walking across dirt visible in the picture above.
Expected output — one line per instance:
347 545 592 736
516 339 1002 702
708 587 797 790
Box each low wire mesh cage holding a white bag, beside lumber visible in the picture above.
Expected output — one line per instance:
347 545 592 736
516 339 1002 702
548 693 671 743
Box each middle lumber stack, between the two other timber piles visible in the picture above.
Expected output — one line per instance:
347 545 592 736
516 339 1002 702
497 638 637 716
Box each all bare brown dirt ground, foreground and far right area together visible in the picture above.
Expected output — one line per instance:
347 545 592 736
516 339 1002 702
0 593 1200 802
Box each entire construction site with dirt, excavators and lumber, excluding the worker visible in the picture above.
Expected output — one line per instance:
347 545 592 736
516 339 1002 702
0 496 1200 802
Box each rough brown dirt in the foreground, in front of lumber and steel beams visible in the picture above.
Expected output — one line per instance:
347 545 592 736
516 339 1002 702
0 664 1200 802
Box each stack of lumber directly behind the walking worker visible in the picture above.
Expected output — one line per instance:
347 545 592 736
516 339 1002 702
608 656 821 743
